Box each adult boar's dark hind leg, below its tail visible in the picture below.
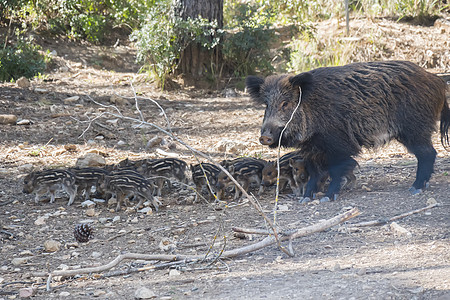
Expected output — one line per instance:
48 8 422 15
404 140 436 195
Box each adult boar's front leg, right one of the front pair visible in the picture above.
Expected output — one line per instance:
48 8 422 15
320 157 358 202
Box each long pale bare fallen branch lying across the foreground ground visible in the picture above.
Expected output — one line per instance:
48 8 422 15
47 208 359 291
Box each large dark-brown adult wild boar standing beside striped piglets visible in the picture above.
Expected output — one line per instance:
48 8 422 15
246 61 450 201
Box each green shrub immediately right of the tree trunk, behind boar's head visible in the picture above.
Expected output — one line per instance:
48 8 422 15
222 3 275 77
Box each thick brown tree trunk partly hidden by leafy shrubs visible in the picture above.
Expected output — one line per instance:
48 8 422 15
174 0 223 85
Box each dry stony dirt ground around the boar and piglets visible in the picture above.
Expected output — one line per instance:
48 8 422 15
0 15 450 299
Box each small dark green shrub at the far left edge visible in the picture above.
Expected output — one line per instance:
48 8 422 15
0 34 47 81
